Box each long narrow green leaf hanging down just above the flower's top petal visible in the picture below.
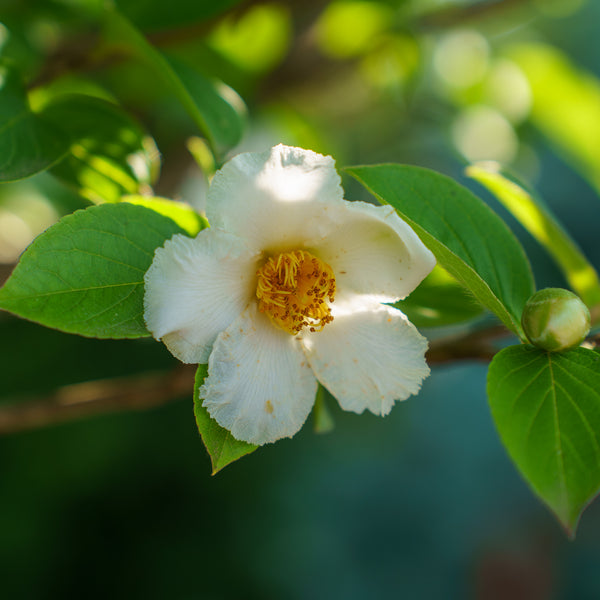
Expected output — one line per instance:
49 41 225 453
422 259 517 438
106 11 246 154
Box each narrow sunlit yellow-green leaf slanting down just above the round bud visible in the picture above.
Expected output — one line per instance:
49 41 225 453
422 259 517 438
467 165 600 308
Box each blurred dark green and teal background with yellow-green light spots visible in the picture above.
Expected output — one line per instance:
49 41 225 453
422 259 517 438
0 0 600 600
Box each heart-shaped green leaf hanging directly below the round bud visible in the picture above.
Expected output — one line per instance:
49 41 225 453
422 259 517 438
487 346 600 536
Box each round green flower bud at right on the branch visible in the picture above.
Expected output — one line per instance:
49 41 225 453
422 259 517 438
521 288 590 352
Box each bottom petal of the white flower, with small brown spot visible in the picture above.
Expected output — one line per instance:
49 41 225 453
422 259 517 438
200 303 317 444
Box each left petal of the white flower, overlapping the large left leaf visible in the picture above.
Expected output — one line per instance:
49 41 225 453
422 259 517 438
144 228 257 363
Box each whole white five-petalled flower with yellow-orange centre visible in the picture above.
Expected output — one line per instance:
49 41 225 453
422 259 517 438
144 145 435 444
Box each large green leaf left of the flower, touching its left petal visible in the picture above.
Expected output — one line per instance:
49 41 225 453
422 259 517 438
0 203 184 338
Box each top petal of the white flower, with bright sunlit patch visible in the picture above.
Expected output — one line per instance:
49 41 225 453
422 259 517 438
206 145 343 252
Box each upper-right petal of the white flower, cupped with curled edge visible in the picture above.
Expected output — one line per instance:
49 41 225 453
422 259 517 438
306 202 435 302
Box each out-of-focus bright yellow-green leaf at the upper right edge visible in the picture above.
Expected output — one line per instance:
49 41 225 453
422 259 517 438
509 43 600 191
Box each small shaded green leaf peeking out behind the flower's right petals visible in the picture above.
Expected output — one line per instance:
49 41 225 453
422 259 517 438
394 265 483 328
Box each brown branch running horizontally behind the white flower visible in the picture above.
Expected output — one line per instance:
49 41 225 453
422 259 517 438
0 326 508 435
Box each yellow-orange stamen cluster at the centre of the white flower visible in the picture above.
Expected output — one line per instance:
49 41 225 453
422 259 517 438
256 250 335 335
